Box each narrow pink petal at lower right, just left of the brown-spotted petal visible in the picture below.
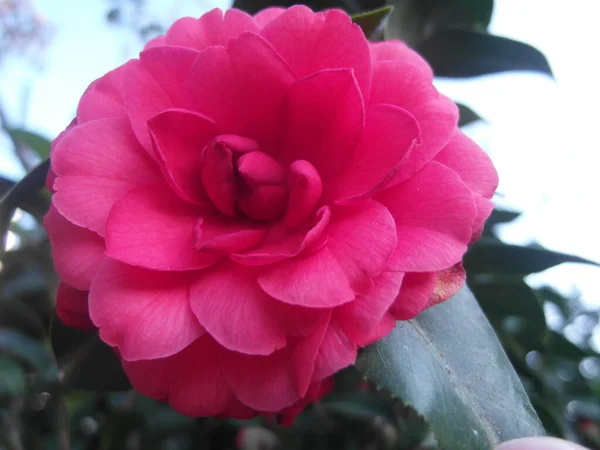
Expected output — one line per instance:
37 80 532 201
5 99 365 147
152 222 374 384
334 272 404 343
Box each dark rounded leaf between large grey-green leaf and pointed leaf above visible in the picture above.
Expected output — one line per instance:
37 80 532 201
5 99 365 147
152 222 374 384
469 278 548 351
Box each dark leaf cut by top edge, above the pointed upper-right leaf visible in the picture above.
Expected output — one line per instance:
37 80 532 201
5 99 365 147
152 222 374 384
385 0 494 48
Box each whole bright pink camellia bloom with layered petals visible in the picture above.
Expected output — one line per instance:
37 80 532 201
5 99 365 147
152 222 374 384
45 6 497 418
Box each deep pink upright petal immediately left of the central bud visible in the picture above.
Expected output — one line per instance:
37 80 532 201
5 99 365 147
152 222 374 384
148 109 219 204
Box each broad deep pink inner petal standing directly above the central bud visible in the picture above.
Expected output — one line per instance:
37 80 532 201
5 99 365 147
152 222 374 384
185 33 294 151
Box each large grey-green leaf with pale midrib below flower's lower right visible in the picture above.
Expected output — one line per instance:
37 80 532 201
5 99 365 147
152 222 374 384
356 288 544 450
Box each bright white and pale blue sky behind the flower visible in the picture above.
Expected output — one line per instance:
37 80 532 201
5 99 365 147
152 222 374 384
0 0 600 307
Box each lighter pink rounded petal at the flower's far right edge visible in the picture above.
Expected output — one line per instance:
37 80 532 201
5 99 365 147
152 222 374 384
435 130 498 198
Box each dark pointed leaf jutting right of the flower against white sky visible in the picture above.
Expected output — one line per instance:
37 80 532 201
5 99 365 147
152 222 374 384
464 237 599 275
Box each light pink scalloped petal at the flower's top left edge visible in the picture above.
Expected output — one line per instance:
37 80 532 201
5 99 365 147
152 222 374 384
165 9 259 50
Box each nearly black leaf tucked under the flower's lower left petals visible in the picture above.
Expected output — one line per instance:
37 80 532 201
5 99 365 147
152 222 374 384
50 315 131 391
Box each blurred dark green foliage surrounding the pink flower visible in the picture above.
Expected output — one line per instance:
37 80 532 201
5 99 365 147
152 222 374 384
0 0 600 450
